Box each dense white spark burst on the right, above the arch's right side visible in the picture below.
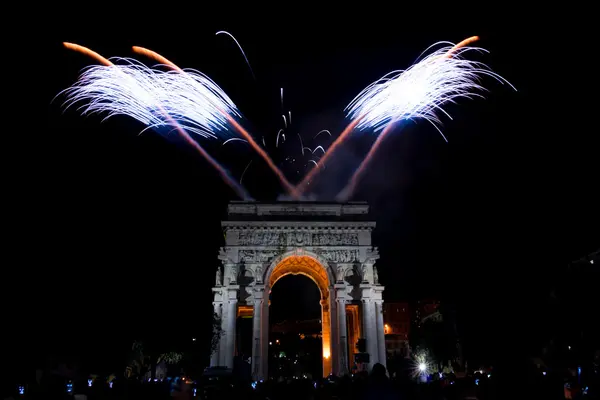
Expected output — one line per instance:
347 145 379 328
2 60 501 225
344 47 516 139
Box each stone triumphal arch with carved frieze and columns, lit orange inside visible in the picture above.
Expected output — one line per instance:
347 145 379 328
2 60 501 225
211 202 386 379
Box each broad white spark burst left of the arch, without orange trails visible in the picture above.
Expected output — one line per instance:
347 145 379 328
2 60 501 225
63 58 240 138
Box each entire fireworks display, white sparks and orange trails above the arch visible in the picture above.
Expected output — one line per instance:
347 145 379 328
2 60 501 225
59 35 514 201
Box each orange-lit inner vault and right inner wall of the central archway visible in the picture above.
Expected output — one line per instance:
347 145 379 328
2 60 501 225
263 254 333 376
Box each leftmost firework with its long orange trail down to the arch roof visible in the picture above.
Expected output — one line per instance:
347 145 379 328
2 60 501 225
64 43 250 200
